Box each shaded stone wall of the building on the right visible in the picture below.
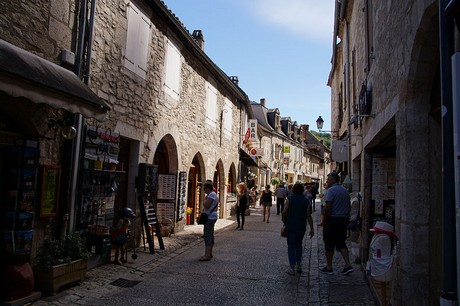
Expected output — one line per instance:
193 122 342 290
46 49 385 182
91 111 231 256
330 0 441 305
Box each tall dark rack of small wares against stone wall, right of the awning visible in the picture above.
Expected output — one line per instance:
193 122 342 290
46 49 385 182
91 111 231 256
78 126 126 262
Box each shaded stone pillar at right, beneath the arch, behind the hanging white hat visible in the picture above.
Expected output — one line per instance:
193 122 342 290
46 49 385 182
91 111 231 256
392 97 430 305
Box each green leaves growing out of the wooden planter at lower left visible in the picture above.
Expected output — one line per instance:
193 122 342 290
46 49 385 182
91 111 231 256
35 232 91 271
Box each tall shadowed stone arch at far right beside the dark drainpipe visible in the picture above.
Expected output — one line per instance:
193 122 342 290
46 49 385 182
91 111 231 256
392 3 442 305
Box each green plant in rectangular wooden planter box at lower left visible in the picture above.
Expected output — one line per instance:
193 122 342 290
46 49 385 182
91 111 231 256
34 232 91 294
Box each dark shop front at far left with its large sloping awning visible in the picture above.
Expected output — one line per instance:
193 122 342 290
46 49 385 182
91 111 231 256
0 40 110 298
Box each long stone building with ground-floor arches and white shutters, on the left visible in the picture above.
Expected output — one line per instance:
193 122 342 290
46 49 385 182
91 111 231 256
0 0 252 286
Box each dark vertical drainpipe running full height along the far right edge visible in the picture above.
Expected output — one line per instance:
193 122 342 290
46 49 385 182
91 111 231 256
439 0 457 306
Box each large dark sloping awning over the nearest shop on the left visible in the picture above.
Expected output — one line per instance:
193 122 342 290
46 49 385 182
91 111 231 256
0 39 110 121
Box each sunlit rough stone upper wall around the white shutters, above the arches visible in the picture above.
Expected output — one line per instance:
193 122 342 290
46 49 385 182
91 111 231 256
91 1 240 175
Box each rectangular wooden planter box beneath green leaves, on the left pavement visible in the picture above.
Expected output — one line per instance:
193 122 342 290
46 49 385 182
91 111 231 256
34 259 88 294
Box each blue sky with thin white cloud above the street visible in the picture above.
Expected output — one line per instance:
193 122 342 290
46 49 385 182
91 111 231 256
164 0 334 130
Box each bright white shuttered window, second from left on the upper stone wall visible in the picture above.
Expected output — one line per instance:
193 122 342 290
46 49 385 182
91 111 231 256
164 40 181 101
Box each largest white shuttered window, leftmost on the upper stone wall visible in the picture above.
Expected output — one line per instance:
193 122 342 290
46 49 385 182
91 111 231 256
124 3 151 79
